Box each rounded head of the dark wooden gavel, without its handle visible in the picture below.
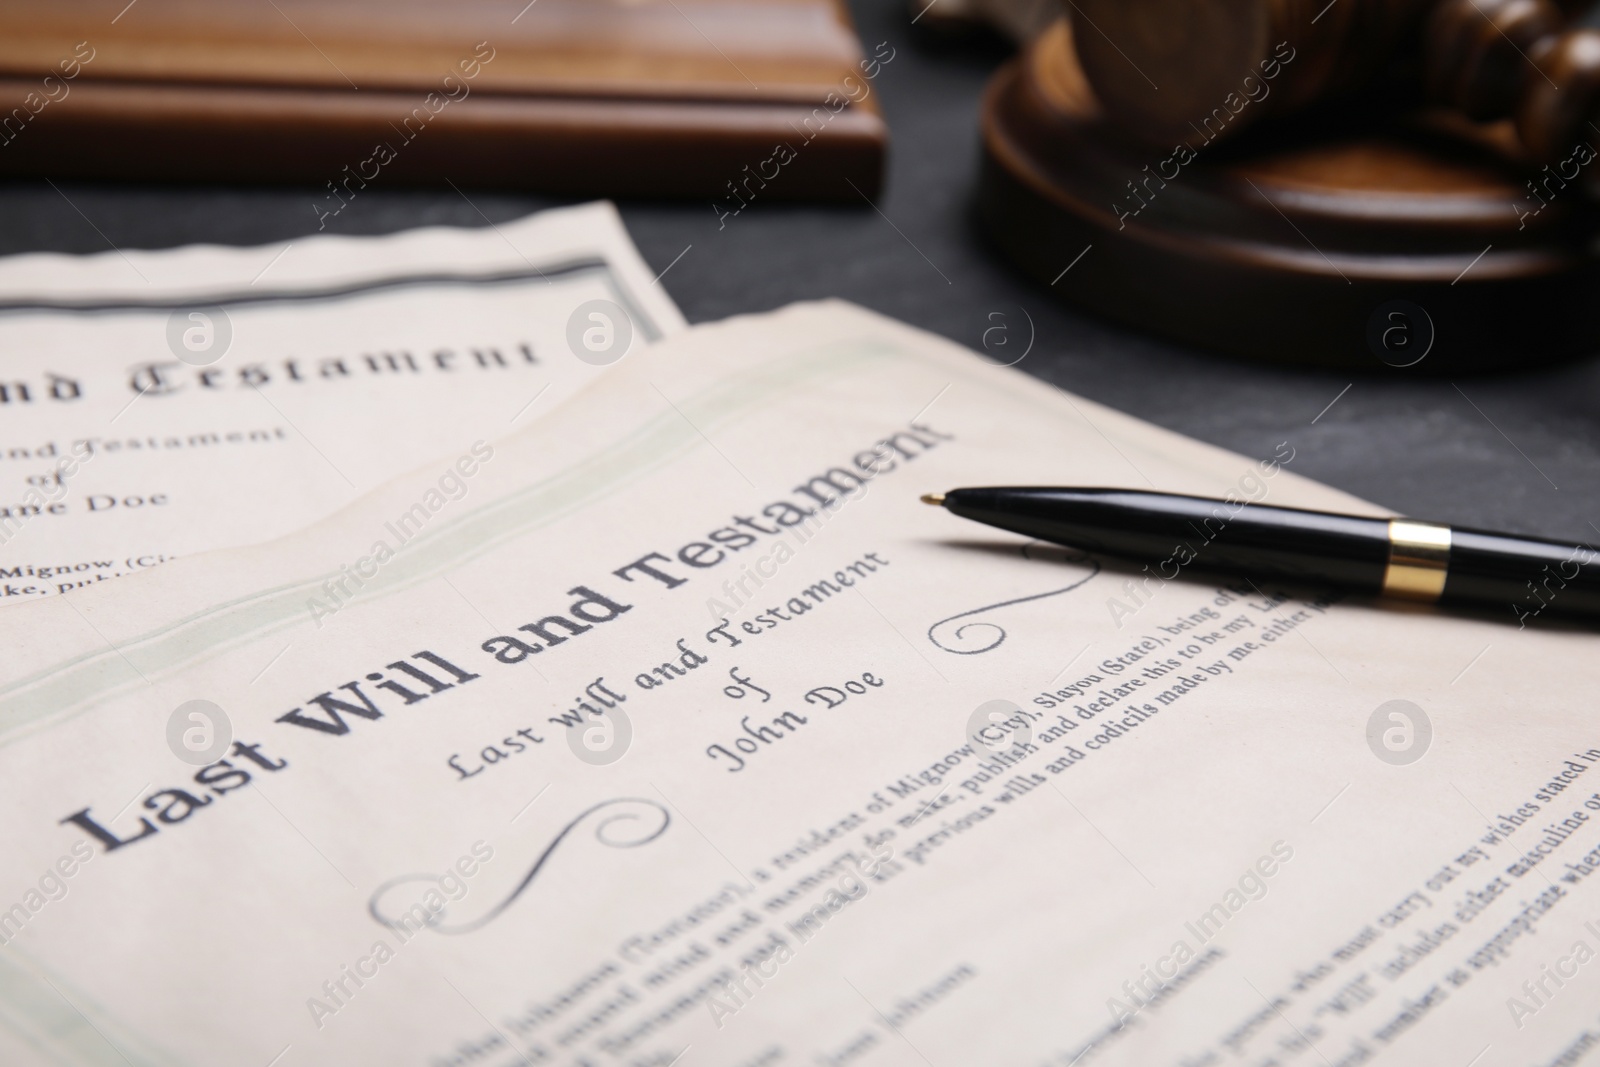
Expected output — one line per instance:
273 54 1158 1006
1066 0 1429 144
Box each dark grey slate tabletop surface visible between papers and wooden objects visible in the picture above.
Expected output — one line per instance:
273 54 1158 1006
0 0 1600 539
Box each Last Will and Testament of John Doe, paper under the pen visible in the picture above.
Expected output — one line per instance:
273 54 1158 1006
0 304 1600 1067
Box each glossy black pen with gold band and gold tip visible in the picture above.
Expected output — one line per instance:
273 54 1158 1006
922 486 1600 625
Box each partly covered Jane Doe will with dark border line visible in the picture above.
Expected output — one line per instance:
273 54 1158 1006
0 203 685 605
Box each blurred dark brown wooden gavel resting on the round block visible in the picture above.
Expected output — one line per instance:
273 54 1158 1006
1066 0 1600 163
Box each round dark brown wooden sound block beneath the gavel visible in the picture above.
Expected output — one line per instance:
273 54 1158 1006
979 22 1600 373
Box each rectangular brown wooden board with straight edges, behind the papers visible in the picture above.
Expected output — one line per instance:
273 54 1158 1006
0 0 893 199
